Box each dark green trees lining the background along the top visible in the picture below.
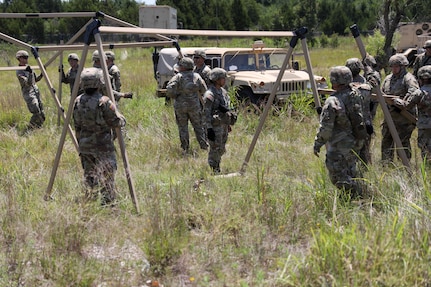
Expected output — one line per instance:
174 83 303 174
0 0 431 44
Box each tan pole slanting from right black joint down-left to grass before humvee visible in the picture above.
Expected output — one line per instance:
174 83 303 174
240 27 306 174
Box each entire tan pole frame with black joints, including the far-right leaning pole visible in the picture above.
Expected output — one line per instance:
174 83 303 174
0 12 410 213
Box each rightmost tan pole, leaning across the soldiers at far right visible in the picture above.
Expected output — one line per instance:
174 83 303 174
350 24 410 168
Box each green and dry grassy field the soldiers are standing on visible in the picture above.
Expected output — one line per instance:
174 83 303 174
0 38 431 287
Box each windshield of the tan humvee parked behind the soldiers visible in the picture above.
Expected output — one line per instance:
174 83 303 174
224 51 286 71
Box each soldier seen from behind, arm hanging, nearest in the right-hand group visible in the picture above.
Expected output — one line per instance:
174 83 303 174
314 66 367 197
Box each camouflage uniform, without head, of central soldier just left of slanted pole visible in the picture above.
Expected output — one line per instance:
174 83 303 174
204 76 231 172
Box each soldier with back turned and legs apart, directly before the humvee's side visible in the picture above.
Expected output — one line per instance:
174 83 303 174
166 58 208 153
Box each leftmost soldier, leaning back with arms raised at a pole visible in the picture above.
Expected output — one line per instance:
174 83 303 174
16 50 45 130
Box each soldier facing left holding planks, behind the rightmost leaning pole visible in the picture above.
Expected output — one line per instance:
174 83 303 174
381 54 420 164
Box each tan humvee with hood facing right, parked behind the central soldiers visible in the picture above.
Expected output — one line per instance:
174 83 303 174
153 43 328 105
